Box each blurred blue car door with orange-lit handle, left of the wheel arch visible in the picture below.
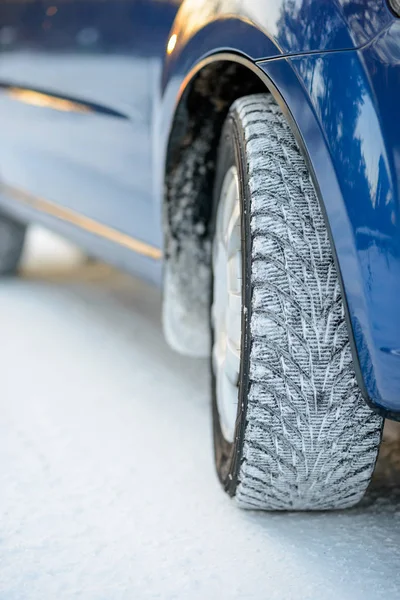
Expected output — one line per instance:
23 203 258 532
0 0 179 245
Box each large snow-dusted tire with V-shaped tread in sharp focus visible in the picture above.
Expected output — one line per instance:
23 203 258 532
211 94 383 510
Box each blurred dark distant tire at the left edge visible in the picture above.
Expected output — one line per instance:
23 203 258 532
0 213 26 276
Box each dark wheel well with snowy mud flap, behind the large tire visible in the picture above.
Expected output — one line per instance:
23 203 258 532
163 60 268 356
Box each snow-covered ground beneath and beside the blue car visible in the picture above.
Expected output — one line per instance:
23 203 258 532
0 226 400 600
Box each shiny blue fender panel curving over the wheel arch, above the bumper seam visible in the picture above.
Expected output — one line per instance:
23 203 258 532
153 0 394 230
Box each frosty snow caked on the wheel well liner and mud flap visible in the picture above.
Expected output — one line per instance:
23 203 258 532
162 122 214 358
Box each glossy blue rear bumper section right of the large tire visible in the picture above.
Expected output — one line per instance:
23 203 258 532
260 20 400 419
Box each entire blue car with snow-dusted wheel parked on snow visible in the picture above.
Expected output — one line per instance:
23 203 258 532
0 0 400 510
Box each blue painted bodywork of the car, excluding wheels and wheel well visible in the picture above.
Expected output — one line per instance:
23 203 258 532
0 0 400 415
